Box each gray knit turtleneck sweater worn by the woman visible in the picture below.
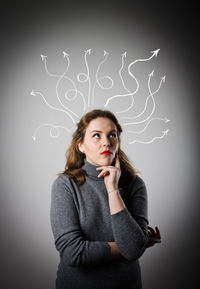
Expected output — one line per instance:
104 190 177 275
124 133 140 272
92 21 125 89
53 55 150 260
51 160 148 289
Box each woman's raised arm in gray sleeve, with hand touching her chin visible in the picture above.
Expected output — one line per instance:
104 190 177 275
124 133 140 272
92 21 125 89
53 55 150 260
97 157 149 260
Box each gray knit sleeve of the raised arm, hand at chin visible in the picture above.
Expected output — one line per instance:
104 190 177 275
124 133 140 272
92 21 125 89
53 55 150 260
111 176 149 260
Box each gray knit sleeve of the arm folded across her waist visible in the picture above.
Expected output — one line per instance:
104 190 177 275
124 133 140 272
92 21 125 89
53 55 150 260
50 177 110 266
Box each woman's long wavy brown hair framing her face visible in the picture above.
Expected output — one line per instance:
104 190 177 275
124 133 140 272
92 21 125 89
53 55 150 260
58 109 138 186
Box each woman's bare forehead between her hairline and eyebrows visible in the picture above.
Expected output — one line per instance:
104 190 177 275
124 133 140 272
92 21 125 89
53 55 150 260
86 117 117 131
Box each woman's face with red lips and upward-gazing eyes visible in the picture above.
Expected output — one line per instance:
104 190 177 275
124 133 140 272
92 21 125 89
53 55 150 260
78 117 119 166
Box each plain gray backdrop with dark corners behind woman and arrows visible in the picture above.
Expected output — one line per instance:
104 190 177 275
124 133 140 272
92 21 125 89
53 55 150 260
0 1 199 289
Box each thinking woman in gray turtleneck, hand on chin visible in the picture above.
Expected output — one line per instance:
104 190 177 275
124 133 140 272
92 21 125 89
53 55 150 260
51 110 160 289
